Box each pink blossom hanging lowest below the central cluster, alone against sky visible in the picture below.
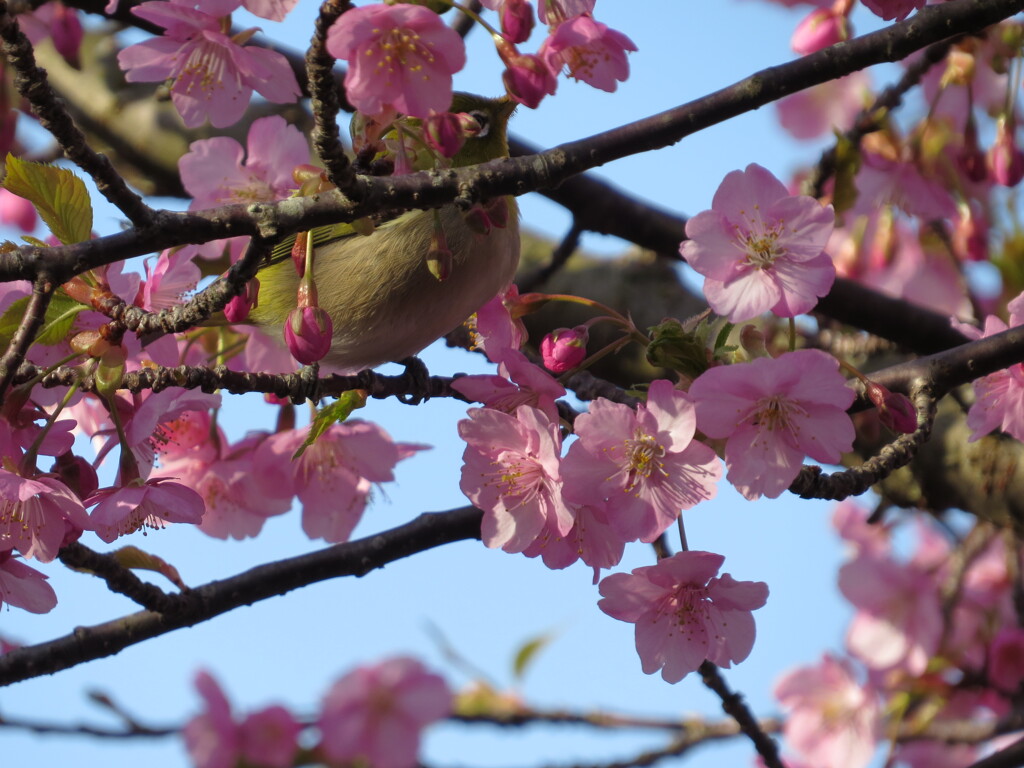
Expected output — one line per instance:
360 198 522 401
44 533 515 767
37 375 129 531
597 552 768 683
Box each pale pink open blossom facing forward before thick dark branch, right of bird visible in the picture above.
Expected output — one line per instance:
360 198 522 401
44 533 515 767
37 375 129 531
679 163 836 323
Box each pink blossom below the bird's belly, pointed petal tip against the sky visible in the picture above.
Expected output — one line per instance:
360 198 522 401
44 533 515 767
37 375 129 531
253 419 417 543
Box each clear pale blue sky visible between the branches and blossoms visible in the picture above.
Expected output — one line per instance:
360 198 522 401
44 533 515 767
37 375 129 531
0 0 909 768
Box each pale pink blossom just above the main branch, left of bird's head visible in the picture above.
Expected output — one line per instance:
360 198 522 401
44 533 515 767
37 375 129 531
178 115 309 210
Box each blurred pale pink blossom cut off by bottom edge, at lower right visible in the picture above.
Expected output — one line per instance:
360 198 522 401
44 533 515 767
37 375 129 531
775 655 880 768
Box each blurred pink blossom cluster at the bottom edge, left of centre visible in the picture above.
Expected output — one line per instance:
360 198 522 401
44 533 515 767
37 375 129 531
183 656 453 768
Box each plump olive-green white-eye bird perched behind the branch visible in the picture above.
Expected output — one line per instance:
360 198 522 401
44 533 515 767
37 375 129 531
249 93 519 373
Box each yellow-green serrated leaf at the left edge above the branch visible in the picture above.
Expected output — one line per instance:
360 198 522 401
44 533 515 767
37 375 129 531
3 153 92 245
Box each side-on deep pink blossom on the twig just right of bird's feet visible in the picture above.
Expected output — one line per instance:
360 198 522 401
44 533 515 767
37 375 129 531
452 349 565 422
